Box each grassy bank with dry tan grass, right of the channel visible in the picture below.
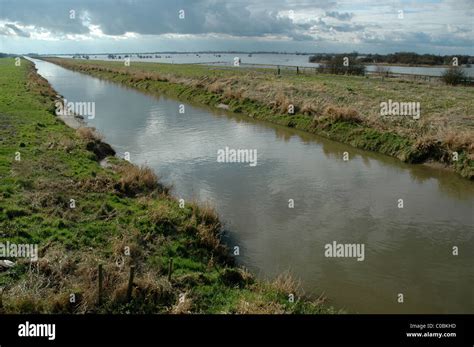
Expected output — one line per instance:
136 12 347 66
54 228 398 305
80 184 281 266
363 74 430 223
47 58 474 179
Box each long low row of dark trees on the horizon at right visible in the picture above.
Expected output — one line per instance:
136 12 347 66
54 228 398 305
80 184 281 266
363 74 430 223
309 52 474 65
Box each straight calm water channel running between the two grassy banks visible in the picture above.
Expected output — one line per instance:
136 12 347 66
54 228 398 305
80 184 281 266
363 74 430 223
31 60 474 313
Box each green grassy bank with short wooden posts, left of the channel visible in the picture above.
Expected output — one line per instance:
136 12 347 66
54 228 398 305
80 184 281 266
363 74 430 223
0 58 333 313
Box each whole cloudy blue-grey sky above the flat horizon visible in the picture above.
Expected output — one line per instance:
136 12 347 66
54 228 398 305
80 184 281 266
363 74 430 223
0 0 474 55
